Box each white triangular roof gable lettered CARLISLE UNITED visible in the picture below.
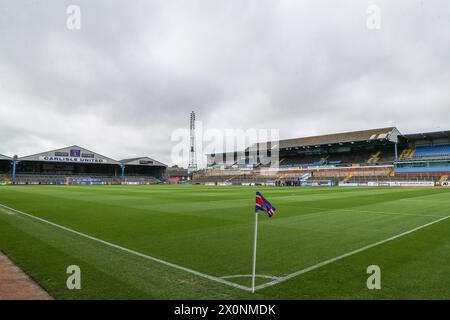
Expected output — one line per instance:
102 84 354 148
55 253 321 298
19 146 120 164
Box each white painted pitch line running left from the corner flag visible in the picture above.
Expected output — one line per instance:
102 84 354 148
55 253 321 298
0 204 252 291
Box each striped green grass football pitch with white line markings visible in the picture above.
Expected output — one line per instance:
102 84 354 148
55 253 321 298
0 185 450 299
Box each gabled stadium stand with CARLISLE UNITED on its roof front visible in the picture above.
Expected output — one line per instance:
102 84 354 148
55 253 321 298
2 146 167 185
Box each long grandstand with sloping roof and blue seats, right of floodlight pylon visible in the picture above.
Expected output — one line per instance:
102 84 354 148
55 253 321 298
199 127 450 185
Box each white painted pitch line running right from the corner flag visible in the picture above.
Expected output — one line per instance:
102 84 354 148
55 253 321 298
255 216 450 290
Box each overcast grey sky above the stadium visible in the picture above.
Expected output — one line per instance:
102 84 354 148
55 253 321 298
0 0 450 164
